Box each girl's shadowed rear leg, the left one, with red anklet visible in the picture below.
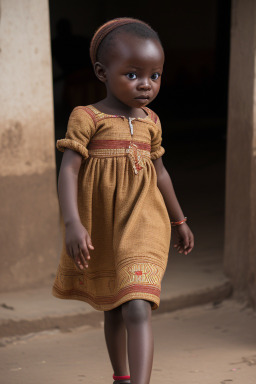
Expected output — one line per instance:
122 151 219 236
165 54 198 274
104 307 130 383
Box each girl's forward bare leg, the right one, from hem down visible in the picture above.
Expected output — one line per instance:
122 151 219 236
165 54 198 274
122 300 154 384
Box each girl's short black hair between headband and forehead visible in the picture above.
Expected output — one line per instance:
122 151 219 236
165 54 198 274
96 23 162 62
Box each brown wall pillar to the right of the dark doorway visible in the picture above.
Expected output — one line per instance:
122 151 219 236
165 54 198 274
224 0 256 305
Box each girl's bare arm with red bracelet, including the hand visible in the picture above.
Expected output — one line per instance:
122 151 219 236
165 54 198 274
153 157 194 255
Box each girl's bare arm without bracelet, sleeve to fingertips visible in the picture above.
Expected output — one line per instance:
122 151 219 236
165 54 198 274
58 149 94 269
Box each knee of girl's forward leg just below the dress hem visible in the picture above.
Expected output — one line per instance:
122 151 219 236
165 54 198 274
122 299 151 324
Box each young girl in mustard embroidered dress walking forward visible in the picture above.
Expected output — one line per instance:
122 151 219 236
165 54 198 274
53 18 194 384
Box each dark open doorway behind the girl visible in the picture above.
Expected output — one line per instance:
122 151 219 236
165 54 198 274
50 0 231 290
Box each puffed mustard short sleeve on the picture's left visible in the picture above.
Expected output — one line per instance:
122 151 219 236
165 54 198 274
56 107 95 159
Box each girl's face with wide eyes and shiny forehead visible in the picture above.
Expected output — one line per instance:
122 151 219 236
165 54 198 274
100 34 164 108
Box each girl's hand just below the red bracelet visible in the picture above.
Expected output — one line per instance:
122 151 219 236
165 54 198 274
173 223 194 255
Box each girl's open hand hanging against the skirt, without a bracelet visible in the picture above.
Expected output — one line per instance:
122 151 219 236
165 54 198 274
66 221 94 269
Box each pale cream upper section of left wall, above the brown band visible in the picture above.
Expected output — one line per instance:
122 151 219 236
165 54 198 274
0 0 54 176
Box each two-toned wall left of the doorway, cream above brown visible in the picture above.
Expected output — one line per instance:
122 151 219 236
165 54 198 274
0 0 59 291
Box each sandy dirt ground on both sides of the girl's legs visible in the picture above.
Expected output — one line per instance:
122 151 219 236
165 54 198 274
0 300 256 384
